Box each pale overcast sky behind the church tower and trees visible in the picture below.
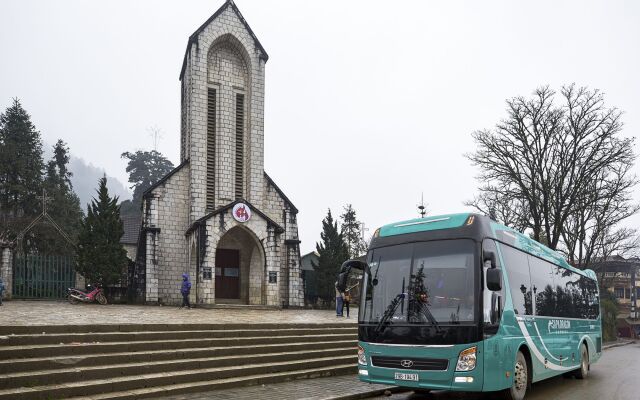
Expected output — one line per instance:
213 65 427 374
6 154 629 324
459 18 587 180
0 0 640 253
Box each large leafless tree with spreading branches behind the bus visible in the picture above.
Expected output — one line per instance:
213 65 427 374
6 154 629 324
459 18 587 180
467 85 638 266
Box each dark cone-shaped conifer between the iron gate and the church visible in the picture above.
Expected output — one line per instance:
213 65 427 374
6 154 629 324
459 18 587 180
76 176 128 285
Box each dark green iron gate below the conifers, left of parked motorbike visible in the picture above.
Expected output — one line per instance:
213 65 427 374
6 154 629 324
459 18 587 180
12 254 76 299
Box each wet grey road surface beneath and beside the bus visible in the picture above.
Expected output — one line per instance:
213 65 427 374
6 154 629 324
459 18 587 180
368 343 640 400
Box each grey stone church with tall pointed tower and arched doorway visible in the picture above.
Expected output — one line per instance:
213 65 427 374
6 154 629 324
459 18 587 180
136 1 304 306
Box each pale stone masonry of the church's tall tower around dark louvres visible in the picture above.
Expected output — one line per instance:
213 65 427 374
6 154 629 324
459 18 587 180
183 4 264 221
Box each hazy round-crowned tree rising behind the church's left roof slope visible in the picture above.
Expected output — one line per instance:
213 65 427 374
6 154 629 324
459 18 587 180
121 150 173 215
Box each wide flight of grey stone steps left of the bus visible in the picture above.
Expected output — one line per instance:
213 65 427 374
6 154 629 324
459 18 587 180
0 324 357 400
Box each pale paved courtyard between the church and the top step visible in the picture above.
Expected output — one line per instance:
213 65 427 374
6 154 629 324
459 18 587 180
0 300 357 326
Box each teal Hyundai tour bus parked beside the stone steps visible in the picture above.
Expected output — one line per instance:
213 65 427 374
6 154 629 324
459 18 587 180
338 213 602 400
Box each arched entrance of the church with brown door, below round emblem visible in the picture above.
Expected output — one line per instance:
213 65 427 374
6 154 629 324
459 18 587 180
215 226 265 305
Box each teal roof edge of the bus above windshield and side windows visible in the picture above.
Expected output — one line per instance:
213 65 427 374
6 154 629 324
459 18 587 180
377 213 595 278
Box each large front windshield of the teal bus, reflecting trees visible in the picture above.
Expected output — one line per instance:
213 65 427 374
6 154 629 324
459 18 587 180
359 239 477 329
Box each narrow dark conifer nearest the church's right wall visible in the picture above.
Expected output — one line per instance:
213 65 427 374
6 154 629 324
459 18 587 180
312 210 349 302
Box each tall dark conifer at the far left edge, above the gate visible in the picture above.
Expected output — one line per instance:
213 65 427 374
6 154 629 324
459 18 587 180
0 99 44 244
